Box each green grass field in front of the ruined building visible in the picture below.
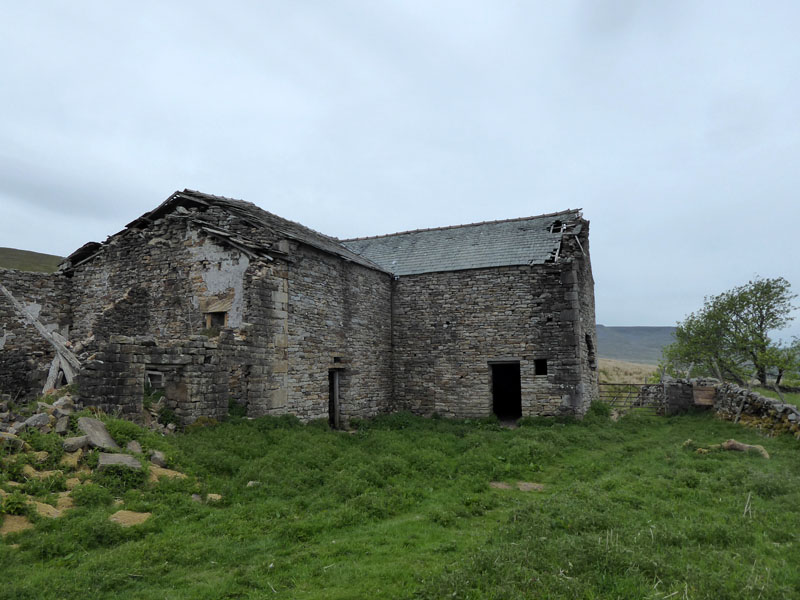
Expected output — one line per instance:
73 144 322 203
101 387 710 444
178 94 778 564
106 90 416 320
0 414 800 600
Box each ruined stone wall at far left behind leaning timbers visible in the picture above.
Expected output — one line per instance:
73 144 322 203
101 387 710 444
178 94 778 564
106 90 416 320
0 269 70 398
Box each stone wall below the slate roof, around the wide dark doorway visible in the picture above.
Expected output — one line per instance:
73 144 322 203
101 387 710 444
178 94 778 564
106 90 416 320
393 263 586 418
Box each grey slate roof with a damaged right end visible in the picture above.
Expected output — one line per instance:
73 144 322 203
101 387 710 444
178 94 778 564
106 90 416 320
342 209 582 275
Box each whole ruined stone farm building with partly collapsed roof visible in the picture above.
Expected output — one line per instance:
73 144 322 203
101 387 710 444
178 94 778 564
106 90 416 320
0 190 597 425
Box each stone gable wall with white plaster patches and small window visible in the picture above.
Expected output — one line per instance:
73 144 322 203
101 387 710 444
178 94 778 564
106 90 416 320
71 215 249 343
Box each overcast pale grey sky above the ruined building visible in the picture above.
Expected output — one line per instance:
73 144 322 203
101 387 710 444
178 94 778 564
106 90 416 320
0 0 800 335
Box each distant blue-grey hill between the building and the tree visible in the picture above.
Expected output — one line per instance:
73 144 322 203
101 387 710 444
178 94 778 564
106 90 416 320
597 325 675 365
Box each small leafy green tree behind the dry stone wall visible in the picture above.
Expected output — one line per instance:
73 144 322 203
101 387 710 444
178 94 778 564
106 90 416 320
664 277 797 386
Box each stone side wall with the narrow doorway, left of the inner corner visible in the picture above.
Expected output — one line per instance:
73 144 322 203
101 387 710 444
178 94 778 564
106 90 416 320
276 245 392 423
